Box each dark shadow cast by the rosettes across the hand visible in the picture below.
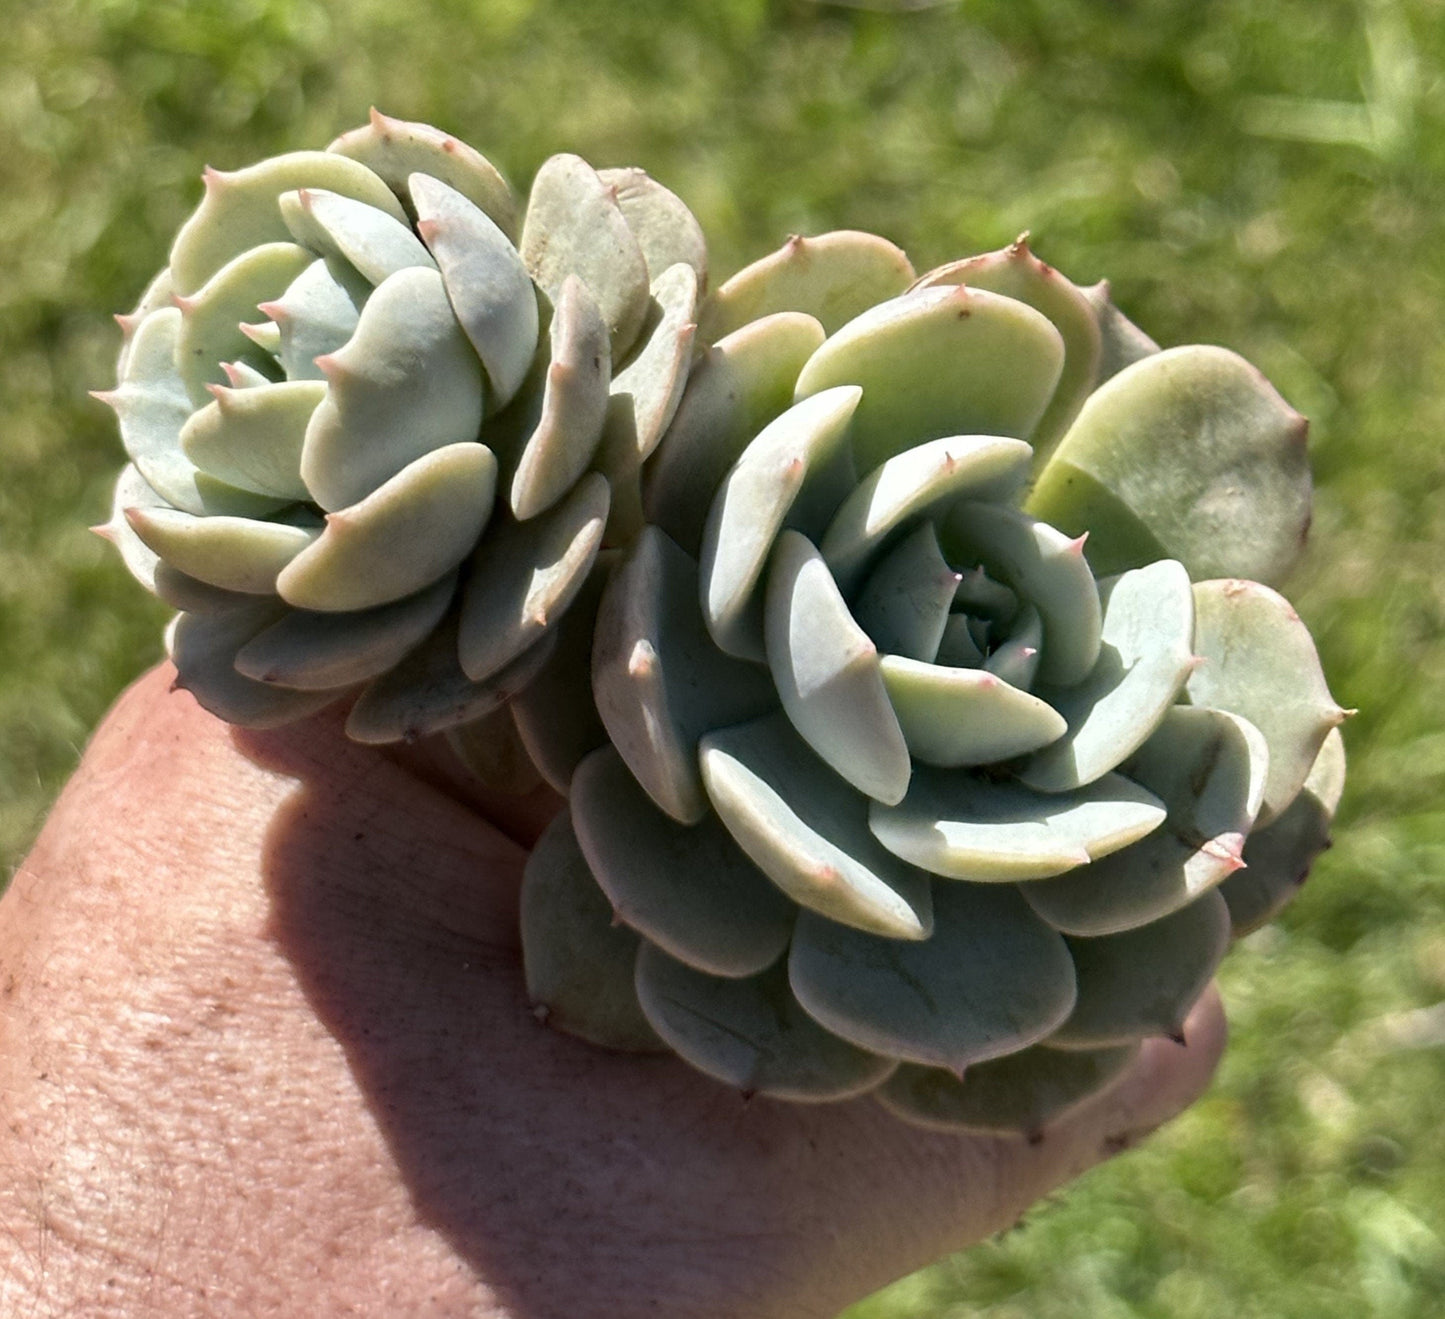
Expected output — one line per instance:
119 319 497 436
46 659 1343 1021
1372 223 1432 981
233 721 893 1319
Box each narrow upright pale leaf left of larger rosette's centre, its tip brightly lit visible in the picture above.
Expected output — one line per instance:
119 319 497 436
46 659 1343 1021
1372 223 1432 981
701 389 860 660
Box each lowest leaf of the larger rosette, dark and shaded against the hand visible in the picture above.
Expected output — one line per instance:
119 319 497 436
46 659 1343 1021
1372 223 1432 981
879 1045 1139 1140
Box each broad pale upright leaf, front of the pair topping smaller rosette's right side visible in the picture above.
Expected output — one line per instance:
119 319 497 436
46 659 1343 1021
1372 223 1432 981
520 155 649 361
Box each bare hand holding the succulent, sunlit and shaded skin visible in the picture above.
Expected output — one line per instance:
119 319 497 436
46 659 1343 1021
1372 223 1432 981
0 670 1224 1319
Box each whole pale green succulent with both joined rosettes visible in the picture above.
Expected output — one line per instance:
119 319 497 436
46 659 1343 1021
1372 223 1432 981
98 117 1345 1133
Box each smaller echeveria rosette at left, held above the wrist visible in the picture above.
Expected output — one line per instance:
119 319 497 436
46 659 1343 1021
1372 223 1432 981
101 113 705 763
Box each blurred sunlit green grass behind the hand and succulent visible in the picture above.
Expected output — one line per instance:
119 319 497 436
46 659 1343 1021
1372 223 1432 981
0 0 1445 1319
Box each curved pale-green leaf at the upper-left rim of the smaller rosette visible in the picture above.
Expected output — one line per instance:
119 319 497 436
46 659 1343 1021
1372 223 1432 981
171 152 406 295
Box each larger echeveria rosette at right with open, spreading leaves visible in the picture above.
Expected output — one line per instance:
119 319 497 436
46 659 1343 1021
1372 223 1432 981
523 234 1344 1133
